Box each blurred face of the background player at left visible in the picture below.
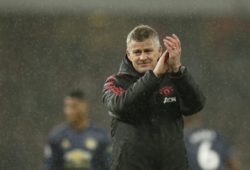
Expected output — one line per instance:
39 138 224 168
64 97 88 123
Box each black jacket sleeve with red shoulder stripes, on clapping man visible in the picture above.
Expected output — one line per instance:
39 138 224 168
103 71 159 117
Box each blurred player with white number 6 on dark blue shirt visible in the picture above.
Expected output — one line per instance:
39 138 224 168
184 114 239 170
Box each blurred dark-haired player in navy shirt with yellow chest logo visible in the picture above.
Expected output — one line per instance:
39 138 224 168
45 90 111 170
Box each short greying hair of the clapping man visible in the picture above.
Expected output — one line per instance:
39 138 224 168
126 25 160 47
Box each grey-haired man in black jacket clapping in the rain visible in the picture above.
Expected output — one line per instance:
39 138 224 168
103 25 204 170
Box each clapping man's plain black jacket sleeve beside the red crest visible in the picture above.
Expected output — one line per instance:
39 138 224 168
171 68 205 116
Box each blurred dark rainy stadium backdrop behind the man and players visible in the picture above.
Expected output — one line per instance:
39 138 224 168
0 0 250 170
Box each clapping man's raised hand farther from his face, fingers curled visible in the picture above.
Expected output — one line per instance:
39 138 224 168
163 34 181 72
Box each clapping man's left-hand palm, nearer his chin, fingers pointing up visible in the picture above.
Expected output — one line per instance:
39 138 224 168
153 50 169 77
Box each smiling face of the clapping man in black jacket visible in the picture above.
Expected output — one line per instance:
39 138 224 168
127 38 162 73
